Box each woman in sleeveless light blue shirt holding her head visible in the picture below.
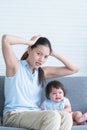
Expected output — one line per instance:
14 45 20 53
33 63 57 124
2 35 79 130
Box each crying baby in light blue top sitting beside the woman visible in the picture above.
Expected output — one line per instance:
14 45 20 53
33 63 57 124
41 80 87 125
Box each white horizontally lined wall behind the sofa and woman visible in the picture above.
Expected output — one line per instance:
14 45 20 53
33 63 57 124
0 0 87 76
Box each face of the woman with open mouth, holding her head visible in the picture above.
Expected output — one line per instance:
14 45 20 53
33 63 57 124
28 45 50 68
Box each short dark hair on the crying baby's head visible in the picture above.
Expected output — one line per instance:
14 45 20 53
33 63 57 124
45 80 65 99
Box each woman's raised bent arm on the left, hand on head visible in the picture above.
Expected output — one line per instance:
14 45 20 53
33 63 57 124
2 35 40 76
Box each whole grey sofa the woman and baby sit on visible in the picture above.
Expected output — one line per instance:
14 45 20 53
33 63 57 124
0 76 87 130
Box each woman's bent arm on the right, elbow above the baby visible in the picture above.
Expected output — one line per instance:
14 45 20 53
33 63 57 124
43 51 80 78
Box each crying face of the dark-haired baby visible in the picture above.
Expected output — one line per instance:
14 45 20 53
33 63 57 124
49 88 64 102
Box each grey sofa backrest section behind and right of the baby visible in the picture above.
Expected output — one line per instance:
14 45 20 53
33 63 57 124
43 76 87 113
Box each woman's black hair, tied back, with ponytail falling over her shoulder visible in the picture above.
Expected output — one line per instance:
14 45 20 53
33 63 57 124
21 37 52 86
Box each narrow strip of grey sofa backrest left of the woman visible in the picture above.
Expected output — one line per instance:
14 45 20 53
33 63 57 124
0 76 5 116
